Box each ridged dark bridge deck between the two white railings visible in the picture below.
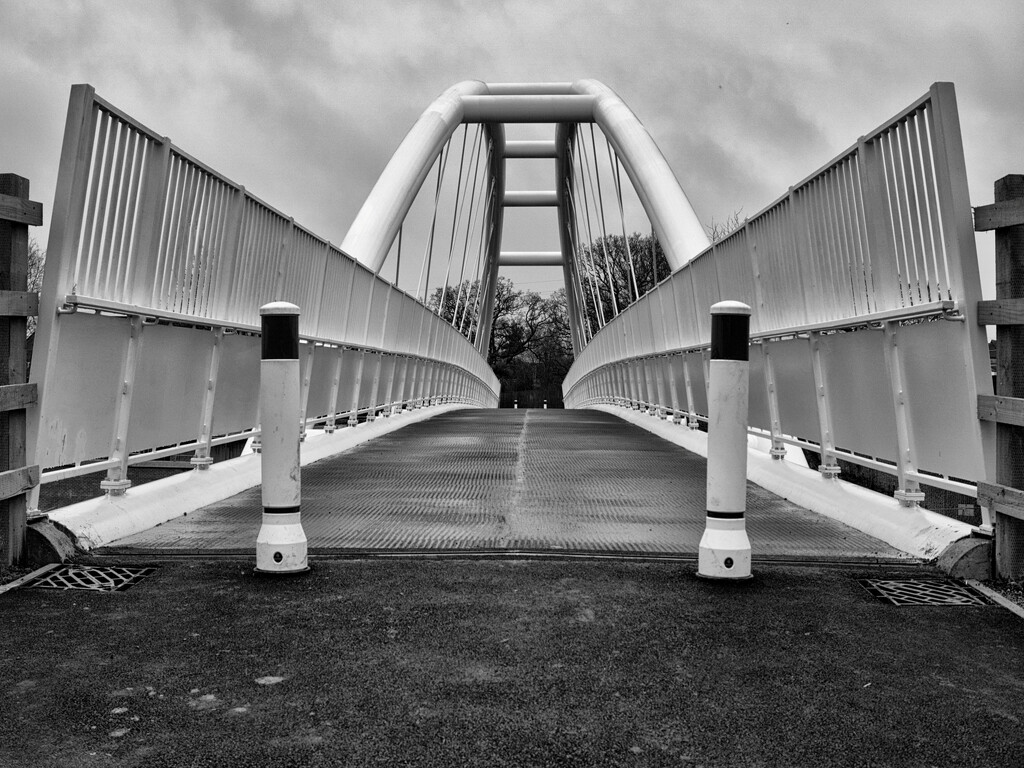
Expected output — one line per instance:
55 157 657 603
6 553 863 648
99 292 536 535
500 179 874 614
99 410 900 560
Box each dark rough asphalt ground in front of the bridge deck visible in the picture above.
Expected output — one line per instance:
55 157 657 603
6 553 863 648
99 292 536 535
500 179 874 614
0 560 1024 768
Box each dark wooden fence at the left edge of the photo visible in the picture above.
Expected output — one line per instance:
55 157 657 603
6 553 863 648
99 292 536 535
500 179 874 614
0 173 43 565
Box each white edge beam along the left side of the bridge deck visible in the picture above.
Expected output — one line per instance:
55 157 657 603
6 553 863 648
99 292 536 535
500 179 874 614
49 403 469 552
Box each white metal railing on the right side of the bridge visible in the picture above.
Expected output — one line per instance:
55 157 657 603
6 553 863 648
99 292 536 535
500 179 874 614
563 83 992 512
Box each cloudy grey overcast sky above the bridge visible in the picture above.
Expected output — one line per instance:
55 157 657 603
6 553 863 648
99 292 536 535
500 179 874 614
0 0 1024 294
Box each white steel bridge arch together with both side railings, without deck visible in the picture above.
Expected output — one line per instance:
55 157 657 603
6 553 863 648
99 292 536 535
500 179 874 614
22 80 993 561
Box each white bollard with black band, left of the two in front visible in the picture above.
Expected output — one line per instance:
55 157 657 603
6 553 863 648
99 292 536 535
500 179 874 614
256 301 309 573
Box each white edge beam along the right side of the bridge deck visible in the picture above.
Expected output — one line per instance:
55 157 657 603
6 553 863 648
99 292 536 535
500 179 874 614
592 406 973 560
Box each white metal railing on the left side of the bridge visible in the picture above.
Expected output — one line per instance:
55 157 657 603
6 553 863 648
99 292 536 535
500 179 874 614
30 85 498 490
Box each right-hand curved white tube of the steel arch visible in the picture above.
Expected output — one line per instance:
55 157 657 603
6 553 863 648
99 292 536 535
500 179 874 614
572 80 711 271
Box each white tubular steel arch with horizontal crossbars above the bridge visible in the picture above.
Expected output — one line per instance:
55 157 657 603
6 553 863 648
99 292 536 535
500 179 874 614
341 80 709 354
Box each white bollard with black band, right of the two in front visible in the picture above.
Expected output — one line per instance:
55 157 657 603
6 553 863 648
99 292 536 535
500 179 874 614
697 301 753 580
